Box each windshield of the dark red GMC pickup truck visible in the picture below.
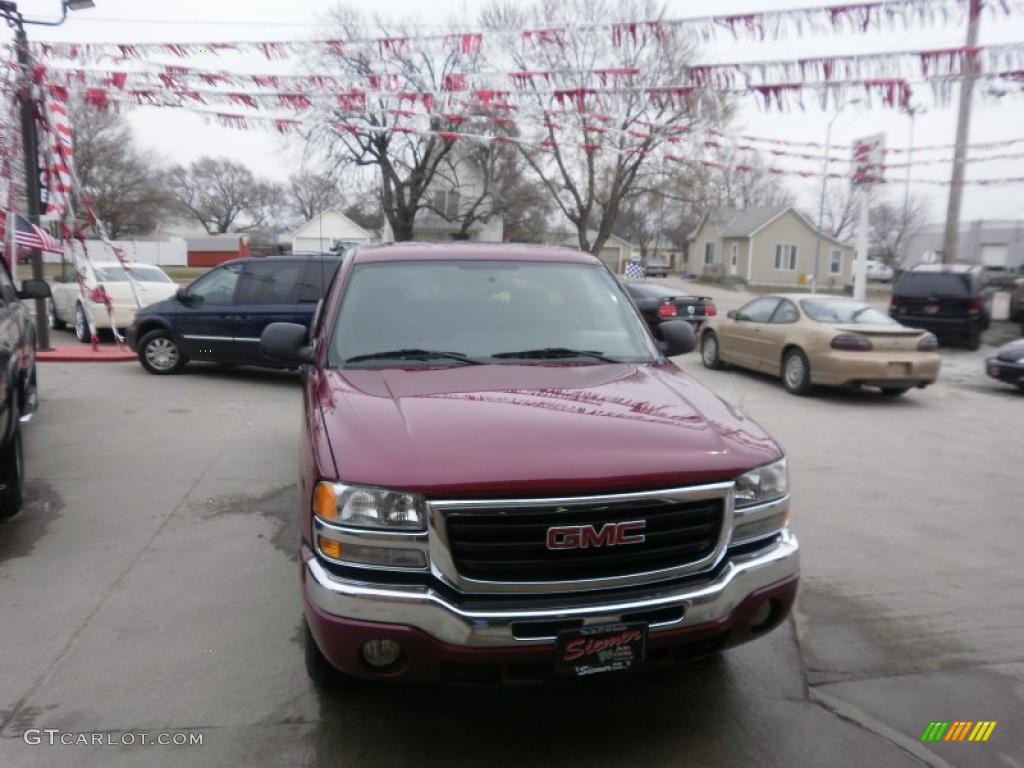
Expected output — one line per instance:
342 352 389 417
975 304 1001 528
328 260 655 368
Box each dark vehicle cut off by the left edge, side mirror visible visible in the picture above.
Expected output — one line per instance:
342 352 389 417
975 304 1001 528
0 270 50 519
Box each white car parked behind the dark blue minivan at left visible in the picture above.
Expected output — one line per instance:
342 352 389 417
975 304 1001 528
48 261 178 344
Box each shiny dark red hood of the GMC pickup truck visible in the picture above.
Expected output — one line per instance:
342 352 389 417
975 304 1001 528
308 364 781 498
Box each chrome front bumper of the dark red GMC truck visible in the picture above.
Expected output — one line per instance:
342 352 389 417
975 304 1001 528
303 528 800 648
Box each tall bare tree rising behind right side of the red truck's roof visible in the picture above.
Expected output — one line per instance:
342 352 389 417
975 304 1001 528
482 0 727 253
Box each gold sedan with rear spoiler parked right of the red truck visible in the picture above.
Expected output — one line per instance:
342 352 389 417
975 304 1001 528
700 294 939 396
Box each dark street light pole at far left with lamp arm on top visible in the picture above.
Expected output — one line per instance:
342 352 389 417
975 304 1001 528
0 0 93 349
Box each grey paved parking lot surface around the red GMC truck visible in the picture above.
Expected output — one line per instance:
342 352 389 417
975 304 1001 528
0 333 1024 768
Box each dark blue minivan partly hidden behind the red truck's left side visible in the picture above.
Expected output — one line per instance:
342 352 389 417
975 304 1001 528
125 254 341 374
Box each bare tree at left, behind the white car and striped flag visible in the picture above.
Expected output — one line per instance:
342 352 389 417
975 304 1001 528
71 103 172 238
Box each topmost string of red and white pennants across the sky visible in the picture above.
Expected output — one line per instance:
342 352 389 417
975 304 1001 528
28 0 1024 61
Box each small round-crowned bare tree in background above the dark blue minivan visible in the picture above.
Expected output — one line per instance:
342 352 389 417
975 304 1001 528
166 157 285 234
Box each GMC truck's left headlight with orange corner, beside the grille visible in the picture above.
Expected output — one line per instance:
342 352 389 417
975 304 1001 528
313 482 427 530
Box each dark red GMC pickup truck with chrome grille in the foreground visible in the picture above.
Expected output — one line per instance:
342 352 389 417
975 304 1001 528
261 244 799 684
